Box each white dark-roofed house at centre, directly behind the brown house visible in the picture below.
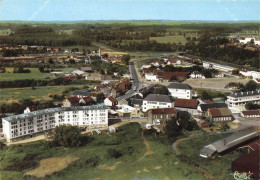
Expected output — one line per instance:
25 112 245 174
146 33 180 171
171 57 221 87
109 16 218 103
142 94 173 112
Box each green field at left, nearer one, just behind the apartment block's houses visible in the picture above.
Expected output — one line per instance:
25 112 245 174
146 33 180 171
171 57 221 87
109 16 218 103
0 84 88 104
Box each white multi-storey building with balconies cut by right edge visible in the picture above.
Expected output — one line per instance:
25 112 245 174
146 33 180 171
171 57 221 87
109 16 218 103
226 90 260 110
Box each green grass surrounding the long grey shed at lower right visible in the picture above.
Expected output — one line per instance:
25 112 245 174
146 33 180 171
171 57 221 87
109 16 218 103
178 134 242 180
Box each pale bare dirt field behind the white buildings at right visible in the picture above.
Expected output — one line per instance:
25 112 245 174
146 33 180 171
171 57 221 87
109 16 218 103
183 77 249 88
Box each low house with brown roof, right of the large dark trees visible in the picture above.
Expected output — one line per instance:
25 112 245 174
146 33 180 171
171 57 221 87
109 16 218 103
206 108 234 122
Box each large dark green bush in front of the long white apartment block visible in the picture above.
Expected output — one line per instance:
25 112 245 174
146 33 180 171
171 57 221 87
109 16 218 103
51 125 81 148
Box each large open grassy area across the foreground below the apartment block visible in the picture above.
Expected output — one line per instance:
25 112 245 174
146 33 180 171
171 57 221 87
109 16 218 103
0 123 203 180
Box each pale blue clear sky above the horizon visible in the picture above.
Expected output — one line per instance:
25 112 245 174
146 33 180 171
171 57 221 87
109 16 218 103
0 0 260 21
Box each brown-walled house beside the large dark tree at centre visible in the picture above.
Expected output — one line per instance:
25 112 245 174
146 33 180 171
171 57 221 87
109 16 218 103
147 108 177 125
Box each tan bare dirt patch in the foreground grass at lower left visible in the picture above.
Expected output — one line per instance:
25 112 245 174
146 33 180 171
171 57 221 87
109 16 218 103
25 158 79 178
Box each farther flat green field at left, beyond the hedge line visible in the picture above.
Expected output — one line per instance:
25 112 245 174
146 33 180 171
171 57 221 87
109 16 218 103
0 68 75 81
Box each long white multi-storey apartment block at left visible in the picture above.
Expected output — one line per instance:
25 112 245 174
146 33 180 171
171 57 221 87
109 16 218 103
2 106 108 142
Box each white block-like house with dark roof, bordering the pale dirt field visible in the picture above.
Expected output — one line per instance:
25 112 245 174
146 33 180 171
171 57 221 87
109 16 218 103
167 83 192 99
